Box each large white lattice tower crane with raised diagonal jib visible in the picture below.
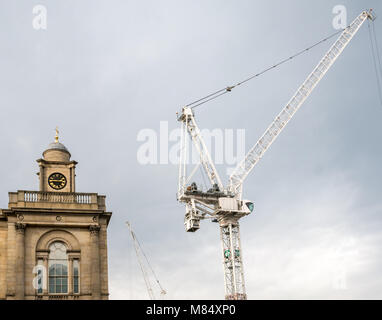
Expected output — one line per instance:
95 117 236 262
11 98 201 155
177 10 375 300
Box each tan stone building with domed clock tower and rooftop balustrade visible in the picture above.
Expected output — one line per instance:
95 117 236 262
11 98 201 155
0 135 111 300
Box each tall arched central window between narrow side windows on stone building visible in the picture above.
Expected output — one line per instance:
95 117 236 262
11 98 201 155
48 241 68 293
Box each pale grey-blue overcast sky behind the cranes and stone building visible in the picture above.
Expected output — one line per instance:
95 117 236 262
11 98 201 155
0 0 382 299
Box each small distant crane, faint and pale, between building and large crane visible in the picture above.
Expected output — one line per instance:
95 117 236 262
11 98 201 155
126 221 166 300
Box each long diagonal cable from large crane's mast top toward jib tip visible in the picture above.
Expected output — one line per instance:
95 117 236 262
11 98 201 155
186 26 356 109
